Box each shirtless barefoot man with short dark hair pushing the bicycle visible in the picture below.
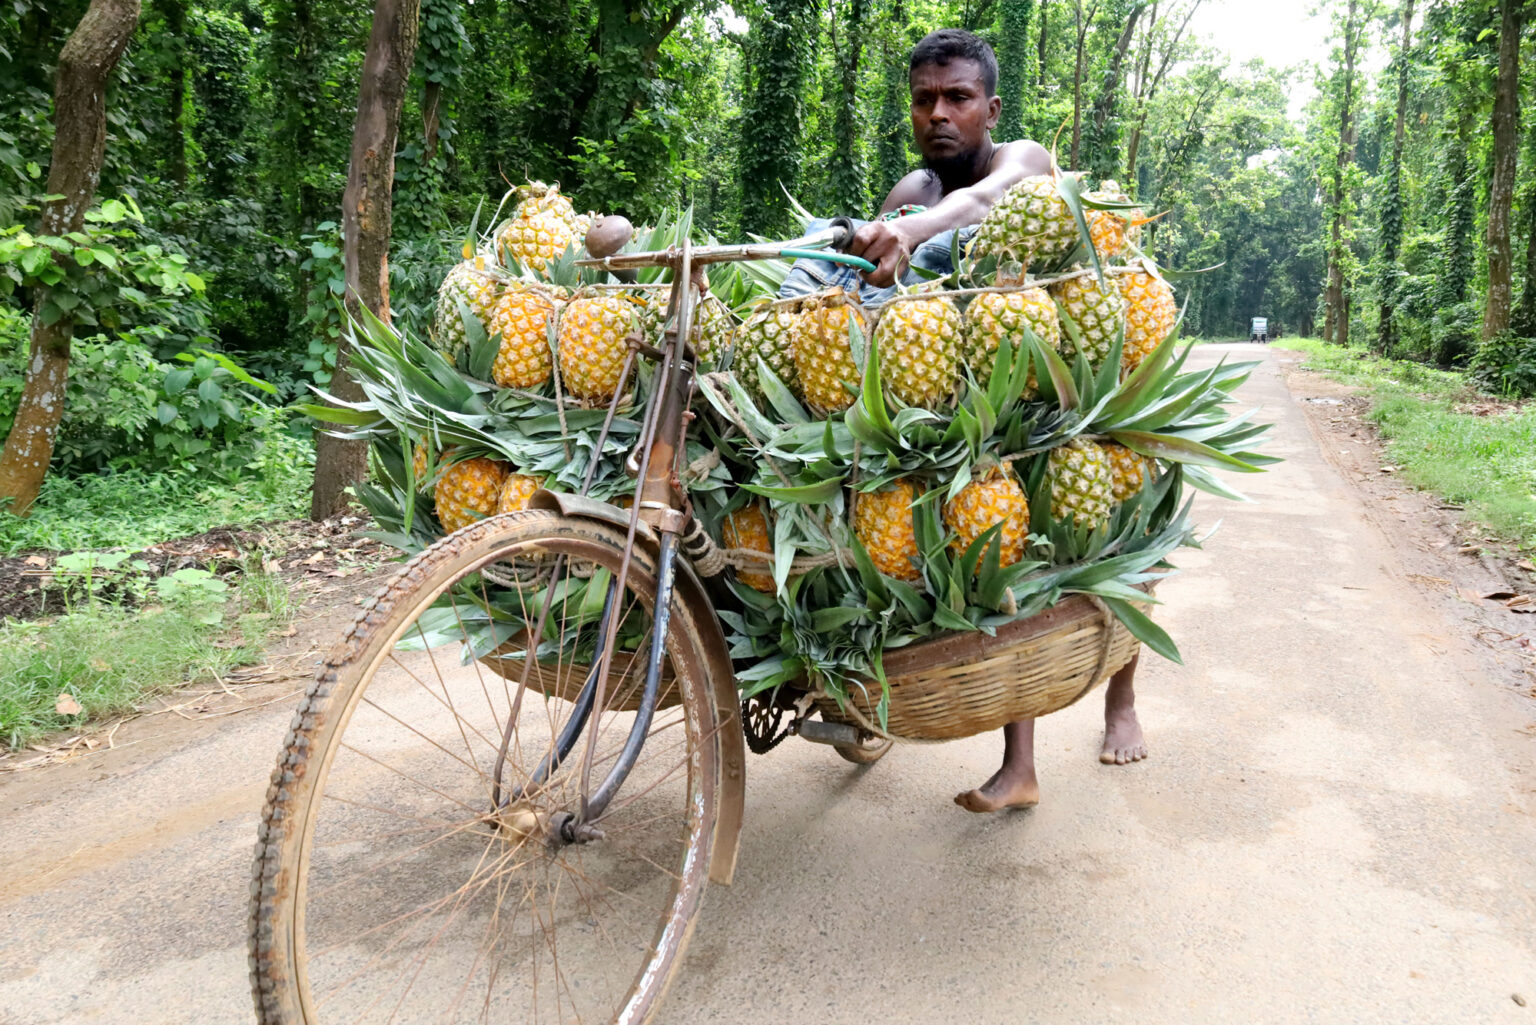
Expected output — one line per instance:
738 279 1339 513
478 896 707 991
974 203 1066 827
849 29 1147 811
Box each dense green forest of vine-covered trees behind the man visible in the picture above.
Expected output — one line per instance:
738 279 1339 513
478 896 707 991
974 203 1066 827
0 0 1536 522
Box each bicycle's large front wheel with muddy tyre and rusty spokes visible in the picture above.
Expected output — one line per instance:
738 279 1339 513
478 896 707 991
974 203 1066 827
250 512 720 1025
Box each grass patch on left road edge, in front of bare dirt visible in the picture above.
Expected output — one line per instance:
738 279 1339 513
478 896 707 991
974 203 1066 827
0 558 292 750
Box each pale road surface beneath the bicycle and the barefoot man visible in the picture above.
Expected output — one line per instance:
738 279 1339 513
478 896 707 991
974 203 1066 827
0 346 1536 1025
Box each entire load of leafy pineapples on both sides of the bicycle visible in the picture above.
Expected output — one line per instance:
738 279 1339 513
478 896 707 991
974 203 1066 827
324 175 1269 706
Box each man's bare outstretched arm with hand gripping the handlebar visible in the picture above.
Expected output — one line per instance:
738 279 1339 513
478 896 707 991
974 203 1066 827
848 141 1054 287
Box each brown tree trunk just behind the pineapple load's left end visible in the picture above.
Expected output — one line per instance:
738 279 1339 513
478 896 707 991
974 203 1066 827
309 0 421 519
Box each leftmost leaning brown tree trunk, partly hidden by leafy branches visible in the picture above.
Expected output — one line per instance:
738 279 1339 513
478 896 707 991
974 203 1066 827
0 0 140 516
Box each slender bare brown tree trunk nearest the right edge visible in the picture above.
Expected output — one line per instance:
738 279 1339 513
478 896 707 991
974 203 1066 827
1482 0 1525 341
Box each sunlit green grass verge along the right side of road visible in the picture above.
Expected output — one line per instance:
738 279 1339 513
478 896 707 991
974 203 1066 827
1275 338 1536 552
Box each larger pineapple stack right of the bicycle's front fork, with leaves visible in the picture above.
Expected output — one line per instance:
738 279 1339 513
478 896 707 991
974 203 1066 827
705 175 1266 693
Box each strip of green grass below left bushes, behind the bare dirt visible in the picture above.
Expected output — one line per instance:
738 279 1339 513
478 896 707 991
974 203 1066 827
0 470 310 555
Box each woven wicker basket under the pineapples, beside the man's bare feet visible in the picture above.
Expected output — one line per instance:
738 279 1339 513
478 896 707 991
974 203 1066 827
817 589 1150 741
